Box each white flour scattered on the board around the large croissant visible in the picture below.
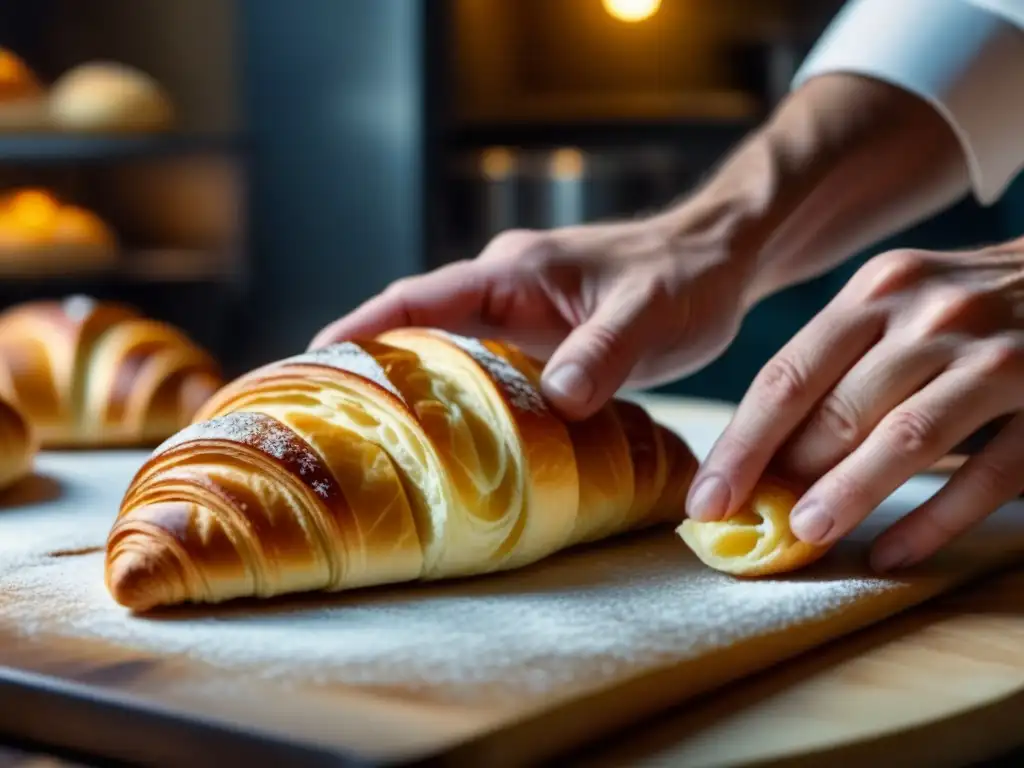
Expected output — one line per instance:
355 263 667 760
6 413 1024 716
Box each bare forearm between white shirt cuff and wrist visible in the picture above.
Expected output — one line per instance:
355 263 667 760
668 75 970 303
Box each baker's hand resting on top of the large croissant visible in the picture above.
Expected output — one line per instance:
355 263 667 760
311 211 749 418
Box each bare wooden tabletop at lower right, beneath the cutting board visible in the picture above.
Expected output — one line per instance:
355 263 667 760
573 567 1024 768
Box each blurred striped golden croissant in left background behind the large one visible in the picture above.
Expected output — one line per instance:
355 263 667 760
0 296 223 449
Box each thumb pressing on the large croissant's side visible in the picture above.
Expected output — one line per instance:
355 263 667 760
541 288 654 419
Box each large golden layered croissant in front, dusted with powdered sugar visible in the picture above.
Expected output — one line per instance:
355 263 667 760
104 329 696 611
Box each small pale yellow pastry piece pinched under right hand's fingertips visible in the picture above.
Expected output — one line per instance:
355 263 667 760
676 475 829 577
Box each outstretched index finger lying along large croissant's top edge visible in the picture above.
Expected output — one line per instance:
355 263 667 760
309 261 493 349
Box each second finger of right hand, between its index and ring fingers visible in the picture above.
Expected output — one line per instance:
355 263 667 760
776 336 954 481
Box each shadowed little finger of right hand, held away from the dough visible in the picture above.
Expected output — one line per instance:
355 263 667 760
870 414 1024 571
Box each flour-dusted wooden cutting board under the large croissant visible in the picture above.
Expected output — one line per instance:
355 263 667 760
0 400 1024 766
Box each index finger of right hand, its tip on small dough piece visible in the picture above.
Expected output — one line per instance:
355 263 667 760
687 305 884 520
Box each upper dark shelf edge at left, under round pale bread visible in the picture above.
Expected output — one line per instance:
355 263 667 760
0 133 244 163
